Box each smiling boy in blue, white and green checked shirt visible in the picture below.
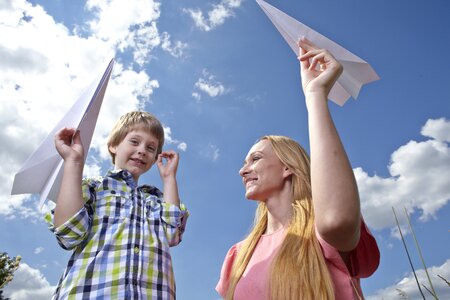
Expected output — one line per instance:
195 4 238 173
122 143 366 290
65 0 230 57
46 111 189 299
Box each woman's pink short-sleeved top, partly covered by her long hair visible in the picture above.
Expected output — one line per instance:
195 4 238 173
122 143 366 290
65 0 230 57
216 222 380 300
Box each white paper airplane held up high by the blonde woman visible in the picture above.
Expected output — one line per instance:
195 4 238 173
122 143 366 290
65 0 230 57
256 0 380 106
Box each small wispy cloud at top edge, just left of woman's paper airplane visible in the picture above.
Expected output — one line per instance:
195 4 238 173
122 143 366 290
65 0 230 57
184 0 241 31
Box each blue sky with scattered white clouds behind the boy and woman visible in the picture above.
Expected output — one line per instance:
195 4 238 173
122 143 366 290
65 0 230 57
0 0 450 300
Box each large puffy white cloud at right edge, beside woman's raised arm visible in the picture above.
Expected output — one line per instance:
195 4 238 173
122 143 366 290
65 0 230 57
354 119 450 229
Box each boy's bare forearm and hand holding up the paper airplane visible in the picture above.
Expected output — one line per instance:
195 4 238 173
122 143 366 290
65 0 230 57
54 128 84 227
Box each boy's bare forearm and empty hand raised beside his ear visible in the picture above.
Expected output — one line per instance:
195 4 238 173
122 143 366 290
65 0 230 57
156 150 180 207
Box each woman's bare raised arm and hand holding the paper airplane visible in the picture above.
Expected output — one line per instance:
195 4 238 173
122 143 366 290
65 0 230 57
299 39 361 252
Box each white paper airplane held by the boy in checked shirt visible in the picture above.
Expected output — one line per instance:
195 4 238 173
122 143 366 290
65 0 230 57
11 59 114 207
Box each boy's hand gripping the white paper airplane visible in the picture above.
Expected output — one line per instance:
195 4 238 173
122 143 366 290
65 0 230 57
55 127 84 163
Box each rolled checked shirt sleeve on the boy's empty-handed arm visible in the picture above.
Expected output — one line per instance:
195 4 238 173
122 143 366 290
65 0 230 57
161 202 189 247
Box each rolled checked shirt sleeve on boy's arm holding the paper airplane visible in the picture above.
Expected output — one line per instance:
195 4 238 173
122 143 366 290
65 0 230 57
44 179 96 250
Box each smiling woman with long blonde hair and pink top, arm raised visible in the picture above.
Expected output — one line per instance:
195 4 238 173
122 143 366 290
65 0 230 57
216 39 379 300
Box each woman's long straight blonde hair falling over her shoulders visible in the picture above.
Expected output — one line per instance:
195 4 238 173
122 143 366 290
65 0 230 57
226 135 334 300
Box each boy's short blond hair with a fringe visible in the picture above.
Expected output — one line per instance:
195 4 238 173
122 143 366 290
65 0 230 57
107 111 164 164
